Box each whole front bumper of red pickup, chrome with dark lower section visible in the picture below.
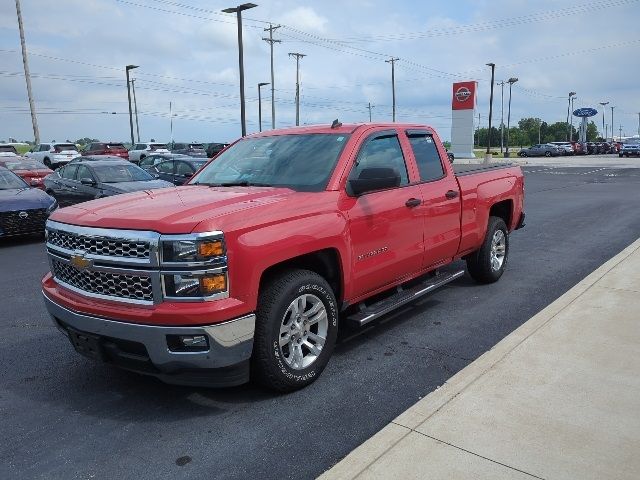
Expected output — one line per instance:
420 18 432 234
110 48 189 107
43 293 255 387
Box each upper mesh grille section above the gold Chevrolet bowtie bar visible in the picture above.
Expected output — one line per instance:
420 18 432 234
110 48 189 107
47 230 150 258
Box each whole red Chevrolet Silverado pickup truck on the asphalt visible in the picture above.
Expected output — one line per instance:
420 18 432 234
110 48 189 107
42 122 524 391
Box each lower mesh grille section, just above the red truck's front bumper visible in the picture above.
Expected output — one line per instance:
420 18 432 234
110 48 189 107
51 258 153 302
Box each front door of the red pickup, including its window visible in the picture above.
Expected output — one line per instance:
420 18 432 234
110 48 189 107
344 130 424 298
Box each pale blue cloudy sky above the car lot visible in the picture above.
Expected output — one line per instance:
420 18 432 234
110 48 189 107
0 0 640 142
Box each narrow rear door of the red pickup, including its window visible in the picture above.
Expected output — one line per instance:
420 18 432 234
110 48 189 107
405 130 461 269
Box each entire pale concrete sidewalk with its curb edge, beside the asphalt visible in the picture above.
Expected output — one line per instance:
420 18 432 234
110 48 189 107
320 240 640 480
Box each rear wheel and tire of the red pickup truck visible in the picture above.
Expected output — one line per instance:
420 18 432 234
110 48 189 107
467 217 509 283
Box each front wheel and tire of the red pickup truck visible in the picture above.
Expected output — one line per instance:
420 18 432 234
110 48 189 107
251 270 338 392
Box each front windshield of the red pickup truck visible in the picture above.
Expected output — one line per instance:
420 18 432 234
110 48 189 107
189 133 349 192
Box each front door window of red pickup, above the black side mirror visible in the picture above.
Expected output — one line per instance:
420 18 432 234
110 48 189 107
349 134 409 186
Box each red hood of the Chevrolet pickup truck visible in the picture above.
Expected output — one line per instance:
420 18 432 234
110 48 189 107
51 185 300 234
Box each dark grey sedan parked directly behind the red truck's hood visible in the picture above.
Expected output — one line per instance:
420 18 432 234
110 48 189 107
44 160 173 206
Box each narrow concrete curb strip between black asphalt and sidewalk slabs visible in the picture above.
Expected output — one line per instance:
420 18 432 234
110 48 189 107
318 239 640 480
